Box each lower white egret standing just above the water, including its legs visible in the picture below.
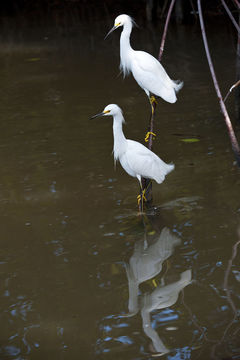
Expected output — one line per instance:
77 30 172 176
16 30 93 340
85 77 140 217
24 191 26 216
92 104 174 204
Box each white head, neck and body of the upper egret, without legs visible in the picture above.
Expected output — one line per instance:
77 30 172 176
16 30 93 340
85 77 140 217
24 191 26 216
107 15 183 103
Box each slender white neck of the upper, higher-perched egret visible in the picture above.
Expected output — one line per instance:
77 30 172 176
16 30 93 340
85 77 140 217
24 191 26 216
120 22 134 76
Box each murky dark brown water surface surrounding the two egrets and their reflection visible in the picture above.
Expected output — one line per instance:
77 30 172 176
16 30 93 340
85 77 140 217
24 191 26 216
0 19 240 360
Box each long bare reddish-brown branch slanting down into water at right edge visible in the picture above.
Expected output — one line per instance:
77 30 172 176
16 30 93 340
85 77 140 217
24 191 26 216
197 0 240 167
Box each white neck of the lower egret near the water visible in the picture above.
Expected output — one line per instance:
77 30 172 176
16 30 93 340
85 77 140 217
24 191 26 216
113 113 127 160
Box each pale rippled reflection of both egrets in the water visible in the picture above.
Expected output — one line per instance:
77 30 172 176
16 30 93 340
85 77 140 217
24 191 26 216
126 218 192 355
